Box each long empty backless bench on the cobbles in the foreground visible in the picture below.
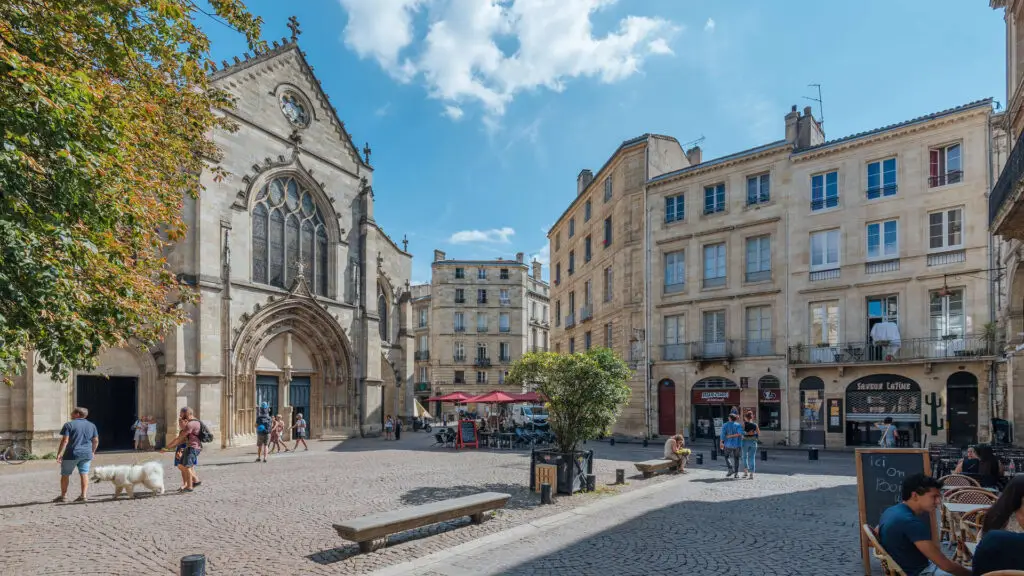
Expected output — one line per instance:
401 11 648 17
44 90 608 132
334 492 512 552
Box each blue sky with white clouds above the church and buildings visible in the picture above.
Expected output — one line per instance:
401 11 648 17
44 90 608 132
199 0 1006 284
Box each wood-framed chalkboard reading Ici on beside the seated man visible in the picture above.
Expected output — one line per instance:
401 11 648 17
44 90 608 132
855 448 938 575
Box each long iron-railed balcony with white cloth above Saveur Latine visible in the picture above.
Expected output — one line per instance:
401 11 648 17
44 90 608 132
790 334 998 365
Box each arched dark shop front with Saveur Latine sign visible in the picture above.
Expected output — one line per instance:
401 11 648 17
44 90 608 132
846 374 921 446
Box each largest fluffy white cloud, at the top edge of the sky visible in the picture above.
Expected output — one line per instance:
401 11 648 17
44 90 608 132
339 0 678 116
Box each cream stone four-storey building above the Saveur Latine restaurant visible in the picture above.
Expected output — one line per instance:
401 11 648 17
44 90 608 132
551 100 996 448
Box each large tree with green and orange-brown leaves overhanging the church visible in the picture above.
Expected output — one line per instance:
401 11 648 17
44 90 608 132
0 0 265 383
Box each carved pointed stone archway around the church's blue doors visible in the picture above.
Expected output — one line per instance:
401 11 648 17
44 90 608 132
230 278 356 444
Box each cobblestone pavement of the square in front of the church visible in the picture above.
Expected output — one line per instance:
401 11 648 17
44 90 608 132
0 433 857 576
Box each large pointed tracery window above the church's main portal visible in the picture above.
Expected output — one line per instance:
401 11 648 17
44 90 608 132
252 176 328 295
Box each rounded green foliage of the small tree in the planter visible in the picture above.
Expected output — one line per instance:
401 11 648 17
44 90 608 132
508 348 632 454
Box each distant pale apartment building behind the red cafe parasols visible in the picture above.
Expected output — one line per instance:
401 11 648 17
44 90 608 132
413 250 551 415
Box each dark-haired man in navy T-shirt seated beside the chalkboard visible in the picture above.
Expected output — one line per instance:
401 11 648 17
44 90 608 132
876 474 971 576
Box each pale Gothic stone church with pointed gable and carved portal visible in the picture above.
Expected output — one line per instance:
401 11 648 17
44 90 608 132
0 29 413 453
